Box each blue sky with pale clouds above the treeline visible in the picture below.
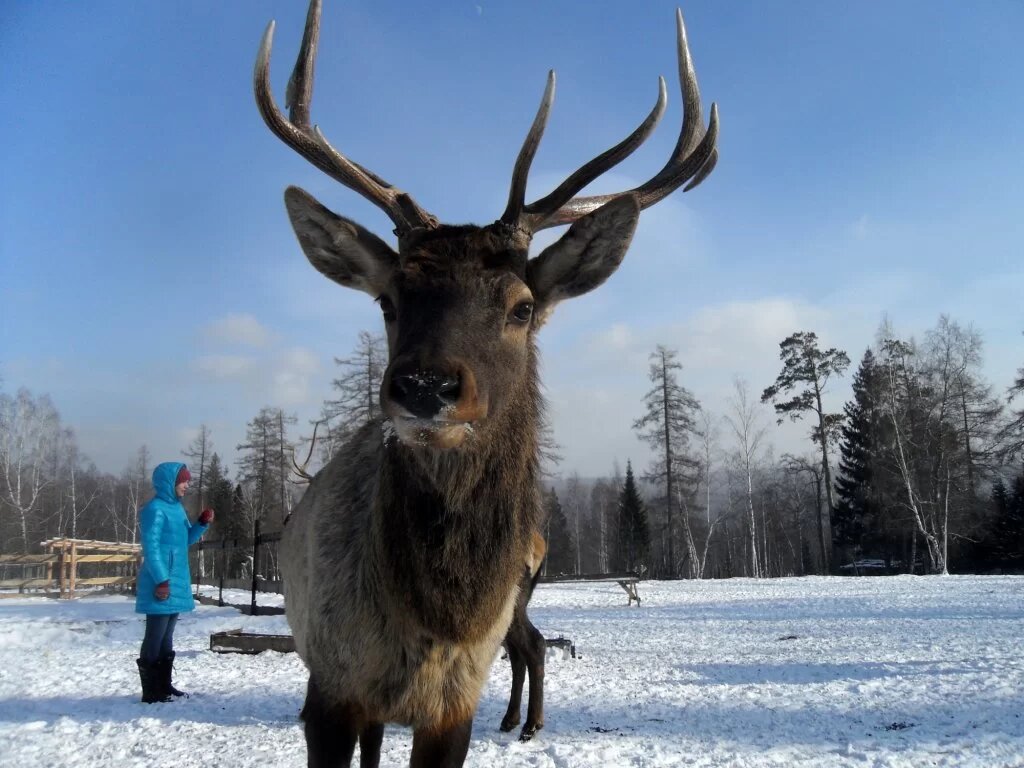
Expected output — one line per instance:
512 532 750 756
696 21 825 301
0 0 1024 475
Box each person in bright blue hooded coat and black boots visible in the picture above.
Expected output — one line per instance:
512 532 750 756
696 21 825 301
135 462 213 703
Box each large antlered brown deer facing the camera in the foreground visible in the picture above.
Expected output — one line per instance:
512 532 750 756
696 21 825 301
253 0 718 768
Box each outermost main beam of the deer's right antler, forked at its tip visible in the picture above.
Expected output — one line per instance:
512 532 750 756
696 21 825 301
525 9 718 231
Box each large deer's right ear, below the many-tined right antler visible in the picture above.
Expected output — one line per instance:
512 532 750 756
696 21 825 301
526 195 640 317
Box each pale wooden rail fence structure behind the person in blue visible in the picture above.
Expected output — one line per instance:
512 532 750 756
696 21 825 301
0 539 141 600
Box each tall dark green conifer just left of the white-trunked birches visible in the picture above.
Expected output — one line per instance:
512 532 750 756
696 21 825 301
833 349 882 559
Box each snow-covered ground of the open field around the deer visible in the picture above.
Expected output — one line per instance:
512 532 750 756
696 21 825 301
0 577 1024 768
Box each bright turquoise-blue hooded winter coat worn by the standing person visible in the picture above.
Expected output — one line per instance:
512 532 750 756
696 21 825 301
135 462 208 613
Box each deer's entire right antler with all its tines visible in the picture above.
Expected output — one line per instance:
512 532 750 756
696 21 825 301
501 9 718 232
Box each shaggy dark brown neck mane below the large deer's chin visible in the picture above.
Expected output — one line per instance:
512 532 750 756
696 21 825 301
374 348 541 642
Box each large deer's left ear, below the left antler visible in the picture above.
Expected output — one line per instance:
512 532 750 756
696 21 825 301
285 186 398 299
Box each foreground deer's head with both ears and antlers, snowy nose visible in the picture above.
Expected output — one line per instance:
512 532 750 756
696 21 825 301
254 0 718 449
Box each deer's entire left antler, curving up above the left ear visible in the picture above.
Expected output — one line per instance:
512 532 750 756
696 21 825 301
253 0 437 234
